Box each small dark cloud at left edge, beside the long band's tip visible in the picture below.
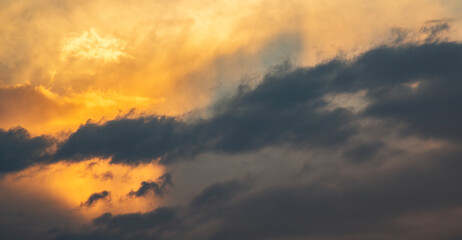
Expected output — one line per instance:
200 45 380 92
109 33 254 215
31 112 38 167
0 127 54 173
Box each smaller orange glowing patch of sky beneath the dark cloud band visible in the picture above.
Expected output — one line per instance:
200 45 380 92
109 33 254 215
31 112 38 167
2 159 164 219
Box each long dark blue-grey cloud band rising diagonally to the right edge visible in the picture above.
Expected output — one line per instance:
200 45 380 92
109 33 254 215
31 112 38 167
52 42 462 163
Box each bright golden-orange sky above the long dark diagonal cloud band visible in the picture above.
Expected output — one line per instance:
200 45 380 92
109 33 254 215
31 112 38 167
0 0 462 135
